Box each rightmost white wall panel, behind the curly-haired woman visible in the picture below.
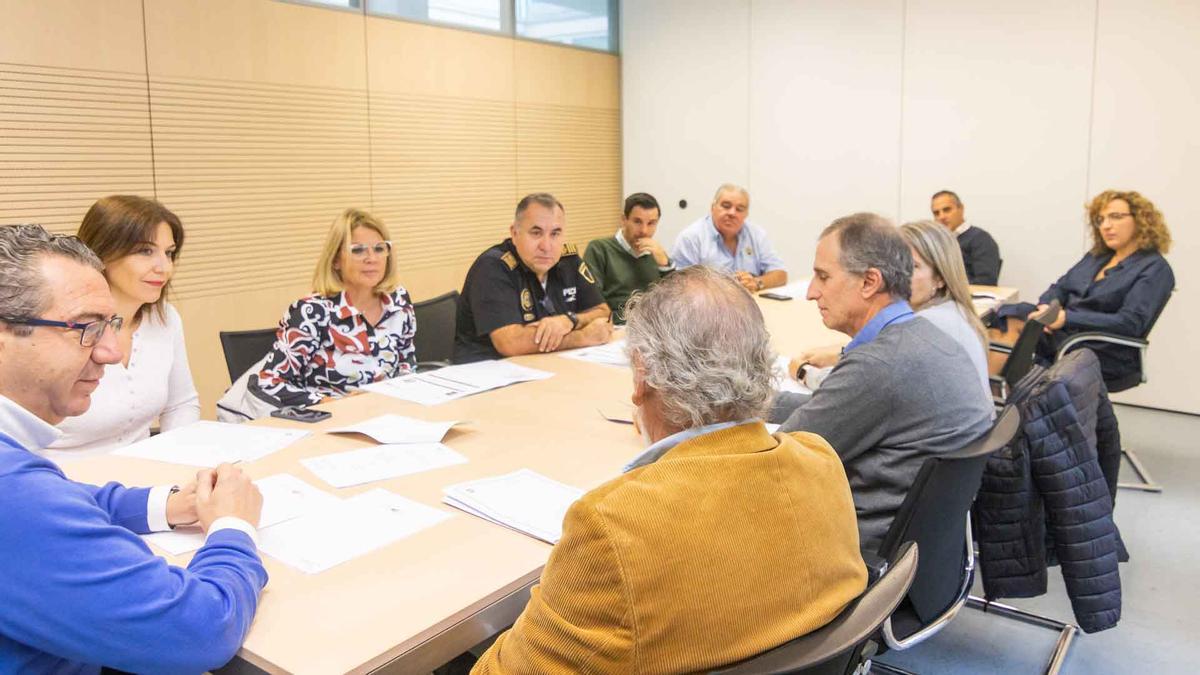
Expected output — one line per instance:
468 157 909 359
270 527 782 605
1088 0 1200 413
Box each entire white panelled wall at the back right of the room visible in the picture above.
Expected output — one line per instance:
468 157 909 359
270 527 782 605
614 0 1200 412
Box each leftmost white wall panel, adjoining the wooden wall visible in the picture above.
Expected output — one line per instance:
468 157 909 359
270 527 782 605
612 0 750 243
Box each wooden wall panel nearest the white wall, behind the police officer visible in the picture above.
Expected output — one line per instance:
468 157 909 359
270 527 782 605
514 41 623 245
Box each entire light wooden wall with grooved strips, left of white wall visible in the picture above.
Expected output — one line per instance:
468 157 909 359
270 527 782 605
9 0 620 417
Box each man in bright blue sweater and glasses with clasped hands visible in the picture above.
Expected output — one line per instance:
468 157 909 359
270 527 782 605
0 225 266 673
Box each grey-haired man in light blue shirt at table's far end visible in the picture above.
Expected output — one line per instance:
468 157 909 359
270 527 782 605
671 183 787 293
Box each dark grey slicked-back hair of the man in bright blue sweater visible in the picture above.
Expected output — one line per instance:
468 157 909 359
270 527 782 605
0 225 104 335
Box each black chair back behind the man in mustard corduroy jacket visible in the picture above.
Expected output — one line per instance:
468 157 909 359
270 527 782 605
713 542 917 675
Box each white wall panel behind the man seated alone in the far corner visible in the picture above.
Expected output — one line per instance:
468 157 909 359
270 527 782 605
901 0 1096 299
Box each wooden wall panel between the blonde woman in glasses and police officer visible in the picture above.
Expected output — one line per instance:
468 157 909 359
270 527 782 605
367 18 516 282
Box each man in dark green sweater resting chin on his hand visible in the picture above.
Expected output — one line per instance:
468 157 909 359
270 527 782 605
583 192 674 325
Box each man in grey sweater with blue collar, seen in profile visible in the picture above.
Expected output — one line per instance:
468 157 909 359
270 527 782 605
770 214 992 550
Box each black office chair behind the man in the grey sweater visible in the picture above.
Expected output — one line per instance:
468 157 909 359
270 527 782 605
864 406 1079 674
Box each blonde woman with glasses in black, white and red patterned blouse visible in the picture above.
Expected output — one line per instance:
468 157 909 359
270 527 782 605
247 209 416 407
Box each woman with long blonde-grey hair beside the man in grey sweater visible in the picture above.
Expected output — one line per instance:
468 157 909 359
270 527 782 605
900 220 991 404
